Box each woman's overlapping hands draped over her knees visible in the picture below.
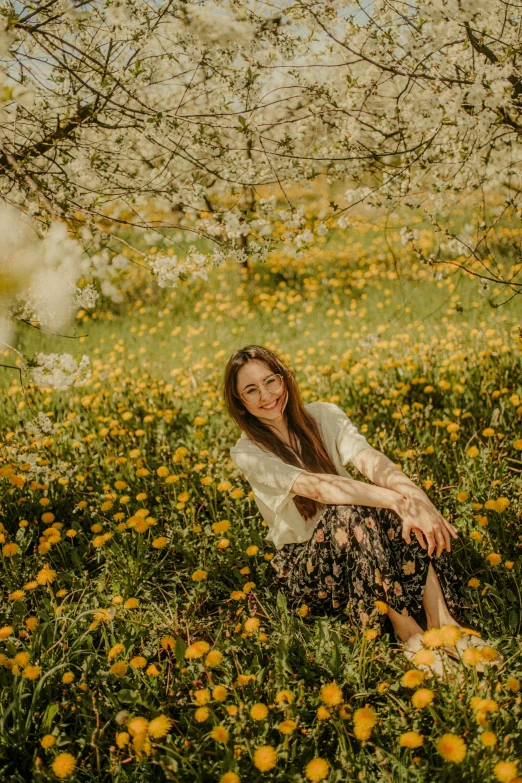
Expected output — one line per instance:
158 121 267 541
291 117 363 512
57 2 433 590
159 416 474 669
395 488 458 557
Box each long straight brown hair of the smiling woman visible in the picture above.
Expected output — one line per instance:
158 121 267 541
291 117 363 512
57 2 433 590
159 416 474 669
224 345 337 519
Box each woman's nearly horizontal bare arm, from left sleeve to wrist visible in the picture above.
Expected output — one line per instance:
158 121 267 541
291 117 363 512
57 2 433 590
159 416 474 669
290 473 401 511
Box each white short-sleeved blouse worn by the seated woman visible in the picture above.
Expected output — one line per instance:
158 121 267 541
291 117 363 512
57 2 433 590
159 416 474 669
230 400 371 549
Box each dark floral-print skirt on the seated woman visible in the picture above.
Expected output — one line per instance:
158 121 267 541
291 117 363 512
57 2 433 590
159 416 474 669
270 505 466 625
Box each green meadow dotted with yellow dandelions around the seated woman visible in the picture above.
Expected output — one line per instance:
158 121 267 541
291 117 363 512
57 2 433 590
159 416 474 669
0 210 522 783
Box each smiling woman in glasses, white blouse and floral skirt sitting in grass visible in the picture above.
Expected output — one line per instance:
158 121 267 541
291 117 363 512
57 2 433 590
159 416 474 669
224 345 500 674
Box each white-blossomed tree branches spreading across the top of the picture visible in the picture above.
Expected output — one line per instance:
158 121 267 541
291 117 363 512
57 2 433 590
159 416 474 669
0 0 522 388
